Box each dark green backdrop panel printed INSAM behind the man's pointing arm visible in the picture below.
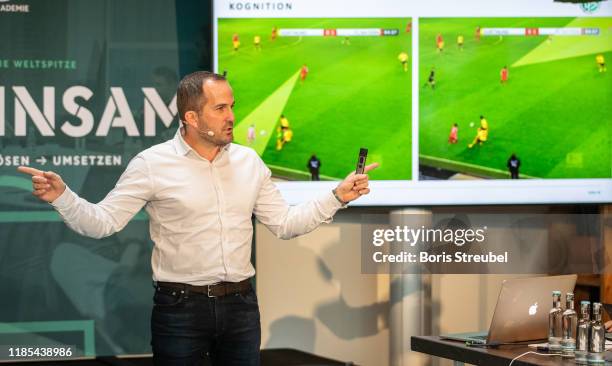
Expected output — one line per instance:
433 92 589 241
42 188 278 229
0 0 211 361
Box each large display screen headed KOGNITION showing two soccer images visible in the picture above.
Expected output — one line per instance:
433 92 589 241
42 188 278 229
213 0 612 205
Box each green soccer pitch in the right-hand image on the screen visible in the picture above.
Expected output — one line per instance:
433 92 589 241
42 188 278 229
419 17 612 178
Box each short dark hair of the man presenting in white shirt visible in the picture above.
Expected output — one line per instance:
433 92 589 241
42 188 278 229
176 71 227 121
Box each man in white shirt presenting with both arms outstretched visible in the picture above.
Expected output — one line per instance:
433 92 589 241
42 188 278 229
18 72 377 366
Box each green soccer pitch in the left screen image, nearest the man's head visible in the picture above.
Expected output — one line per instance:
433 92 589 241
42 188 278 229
218 18 412 180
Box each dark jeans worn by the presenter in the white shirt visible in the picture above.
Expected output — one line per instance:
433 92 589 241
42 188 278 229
151 287 261 366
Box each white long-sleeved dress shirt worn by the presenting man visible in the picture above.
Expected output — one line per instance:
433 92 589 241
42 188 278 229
52 129 342 285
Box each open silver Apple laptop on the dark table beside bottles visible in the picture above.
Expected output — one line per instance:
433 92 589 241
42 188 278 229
440 275 578 345
